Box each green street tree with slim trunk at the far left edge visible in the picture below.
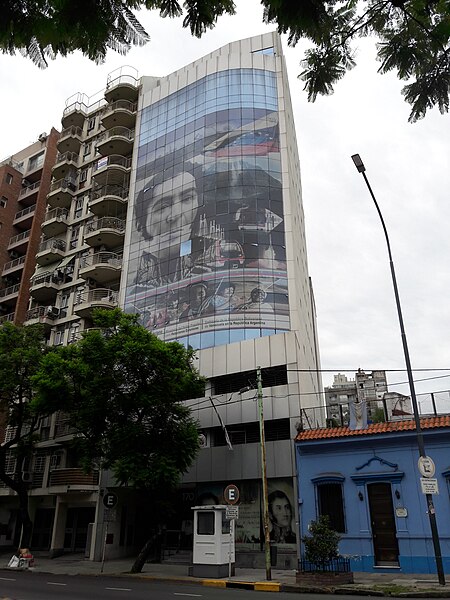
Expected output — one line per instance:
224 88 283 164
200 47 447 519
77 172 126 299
0 323 50 547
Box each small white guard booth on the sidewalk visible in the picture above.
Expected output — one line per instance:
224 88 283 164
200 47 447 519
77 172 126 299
189 505 235 577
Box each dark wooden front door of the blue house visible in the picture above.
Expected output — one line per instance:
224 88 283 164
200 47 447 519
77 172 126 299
367 483 398 567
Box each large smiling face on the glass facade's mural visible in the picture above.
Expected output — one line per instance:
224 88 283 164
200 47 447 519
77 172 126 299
146 172 198 239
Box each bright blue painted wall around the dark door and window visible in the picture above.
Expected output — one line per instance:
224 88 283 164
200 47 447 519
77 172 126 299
296 428 450 573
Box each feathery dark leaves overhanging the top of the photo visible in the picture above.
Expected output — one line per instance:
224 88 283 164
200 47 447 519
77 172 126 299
0 0 450 122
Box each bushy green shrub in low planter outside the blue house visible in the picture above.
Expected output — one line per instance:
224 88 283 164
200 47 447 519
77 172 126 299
297 515 353 585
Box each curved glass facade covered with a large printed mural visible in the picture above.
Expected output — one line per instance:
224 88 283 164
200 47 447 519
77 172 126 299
125 69 289 348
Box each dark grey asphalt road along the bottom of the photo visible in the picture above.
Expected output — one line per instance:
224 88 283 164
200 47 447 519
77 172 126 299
0 571 400 600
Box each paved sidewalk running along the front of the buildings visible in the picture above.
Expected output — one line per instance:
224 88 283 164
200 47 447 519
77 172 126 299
0 553 450 598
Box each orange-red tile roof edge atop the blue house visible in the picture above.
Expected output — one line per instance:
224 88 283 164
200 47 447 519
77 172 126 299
295 415 450 442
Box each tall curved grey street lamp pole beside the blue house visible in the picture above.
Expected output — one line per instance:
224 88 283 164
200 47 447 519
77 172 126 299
352 154 445 585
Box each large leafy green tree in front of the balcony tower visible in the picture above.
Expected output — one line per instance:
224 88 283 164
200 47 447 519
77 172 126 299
34 309 204 572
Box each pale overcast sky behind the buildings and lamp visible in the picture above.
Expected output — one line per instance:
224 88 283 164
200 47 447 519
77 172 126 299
0 0 450 410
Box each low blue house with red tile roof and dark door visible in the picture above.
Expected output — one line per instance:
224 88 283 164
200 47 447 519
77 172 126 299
295 415 450 573
